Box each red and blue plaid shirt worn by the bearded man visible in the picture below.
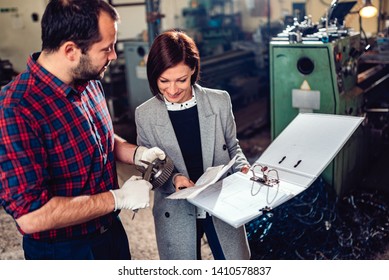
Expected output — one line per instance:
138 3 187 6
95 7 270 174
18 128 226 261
0 53 118 239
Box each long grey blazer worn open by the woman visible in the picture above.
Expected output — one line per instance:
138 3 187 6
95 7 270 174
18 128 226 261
135 85 250 260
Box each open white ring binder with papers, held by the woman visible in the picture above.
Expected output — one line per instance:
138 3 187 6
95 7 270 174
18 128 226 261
170 113 363 228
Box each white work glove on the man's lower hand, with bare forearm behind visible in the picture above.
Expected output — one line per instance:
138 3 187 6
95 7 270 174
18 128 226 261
110 176 153 211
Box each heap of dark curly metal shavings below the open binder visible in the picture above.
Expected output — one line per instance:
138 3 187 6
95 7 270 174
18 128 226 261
246 178 389 260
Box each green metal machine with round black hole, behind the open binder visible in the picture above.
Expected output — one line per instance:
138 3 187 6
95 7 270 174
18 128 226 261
270 1 367 195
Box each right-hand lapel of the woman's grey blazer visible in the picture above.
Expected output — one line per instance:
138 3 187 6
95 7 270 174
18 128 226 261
194 85 216 169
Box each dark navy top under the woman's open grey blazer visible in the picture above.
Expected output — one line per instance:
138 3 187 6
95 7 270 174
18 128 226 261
168 106 204 182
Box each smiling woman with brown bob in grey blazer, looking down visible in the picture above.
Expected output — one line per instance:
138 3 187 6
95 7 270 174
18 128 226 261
135 30 250 259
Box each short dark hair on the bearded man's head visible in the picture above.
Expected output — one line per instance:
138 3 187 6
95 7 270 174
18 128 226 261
41 0 119 53
